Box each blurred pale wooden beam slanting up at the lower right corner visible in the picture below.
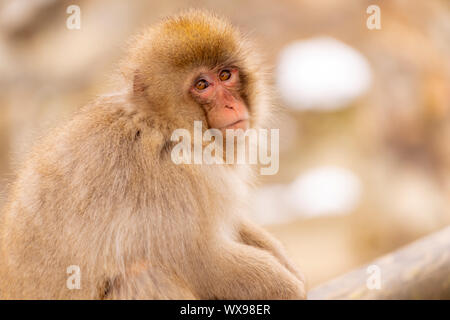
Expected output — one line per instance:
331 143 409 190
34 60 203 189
308 227 450 300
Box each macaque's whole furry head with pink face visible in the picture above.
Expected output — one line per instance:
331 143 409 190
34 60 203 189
121 10 266 137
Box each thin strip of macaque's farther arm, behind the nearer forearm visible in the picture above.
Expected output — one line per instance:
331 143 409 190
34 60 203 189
239 220 305 282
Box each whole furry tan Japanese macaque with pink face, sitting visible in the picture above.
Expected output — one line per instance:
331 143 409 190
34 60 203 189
0 11 306 299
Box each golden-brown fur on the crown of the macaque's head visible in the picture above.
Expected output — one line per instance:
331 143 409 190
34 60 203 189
123 9 247 72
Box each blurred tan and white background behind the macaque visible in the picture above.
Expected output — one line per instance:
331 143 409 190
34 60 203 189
0 0 450 287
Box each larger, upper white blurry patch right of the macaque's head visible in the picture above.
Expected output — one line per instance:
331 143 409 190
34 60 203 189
277 37 372 110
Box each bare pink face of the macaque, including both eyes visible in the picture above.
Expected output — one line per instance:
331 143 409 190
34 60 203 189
190 68 249 132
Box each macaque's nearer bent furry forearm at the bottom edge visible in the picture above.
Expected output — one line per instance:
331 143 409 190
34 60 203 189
198 241 306 300
